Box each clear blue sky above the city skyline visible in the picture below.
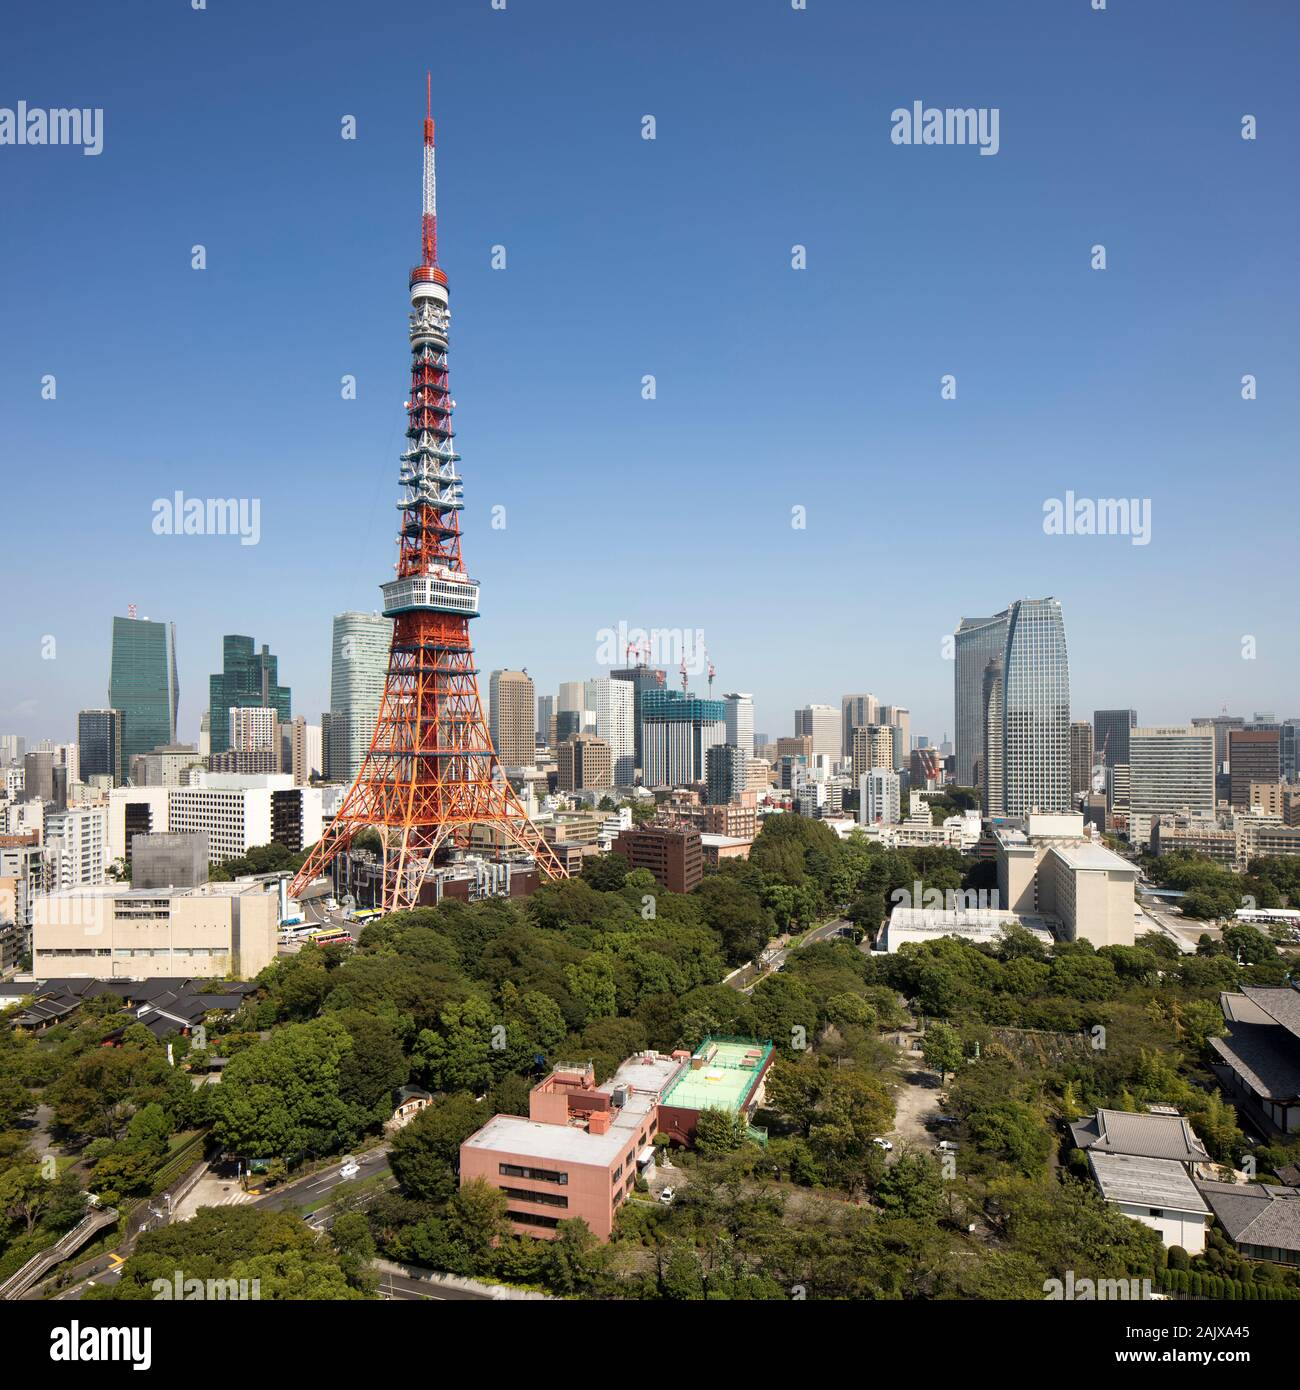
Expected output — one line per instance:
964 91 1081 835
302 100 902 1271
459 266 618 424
0 0 1300 738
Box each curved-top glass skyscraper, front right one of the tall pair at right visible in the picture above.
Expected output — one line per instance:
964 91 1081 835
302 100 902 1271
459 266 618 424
1002 598 1071 816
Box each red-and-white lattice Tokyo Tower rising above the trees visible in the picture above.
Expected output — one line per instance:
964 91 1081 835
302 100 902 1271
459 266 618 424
289 85 567 912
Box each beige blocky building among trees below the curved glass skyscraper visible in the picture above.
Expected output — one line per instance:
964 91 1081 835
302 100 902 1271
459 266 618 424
997 815 1137 947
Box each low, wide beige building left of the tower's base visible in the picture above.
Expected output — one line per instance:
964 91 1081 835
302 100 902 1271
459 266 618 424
32 880 279 980
